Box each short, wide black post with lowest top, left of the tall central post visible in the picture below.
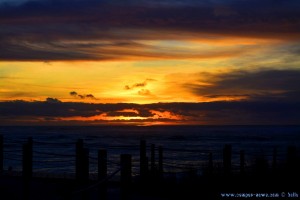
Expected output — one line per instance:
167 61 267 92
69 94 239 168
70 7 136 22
120 154 131 199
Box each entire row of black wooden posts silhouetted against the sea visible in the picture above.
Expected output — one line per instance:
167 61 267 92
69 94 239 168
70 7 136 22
0 135 297 178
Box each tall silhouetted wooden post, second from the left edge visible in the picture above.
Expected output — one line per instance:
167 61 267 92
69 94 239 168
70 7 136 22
22 137 33 200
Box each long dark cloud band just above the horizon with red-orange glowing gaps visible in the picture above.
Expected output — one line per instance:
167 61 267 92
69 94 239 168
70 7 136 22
0 99 300 125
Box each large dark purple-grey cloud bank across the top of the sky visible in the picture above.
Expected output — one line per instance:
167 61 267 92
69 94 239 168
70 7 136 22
0 0 300 61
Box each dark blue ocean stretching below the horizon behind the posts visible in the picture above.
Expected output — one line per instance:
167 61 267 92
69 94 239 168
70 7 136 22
0 126 300 177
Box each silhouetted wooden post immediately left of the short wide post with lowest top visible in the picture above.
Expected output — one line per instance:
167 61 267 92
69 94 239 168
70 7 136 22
98 149 107 200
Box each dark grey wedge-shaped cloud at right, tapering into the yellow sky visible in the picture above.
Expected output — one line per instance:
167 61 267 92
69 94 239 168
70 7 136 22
184 69 300 101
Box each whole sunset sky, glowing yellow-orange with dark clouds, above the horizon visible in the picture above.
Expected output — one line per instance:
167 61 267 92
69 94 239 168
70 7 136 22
0 0 300 125
